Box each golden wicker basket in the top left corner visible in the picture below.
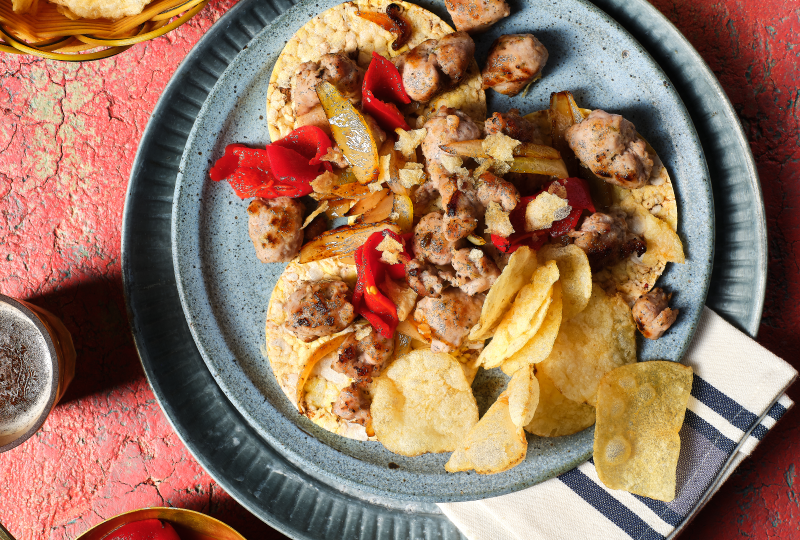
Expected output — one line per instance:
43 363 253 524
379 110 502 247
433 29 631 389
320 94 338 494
0 0 209 62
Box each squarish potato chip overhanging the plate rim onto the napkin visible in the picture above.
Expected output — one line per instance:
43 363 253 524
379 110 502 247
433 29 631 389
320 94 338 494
594 361 692 502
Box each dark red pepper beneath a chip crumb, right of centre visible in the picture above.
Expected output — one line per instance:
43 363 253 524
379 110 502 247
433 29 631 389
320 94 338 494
492 178 595 253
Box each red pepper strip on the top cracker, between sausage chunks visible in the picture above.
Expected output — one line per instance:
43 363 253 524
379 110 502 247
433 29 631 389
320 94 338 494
361 52 411 131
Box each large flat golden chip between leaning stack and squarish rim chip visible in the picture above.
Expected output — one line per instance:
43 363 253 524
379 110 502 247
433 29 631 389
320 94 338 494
536 284 636 406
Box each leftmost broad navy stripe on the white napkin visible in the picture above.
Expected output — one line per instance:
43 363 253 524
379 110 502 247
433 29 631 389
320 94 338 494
558 467 665 540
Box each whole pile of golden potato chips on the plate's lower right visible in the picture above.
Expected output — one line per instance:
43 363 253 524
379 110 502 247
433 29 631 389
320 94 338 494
372 245 691 500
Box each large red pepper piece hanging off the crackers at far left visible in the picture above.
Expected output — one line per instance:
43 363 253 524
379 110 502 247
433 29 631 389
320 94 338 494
208 126 331 199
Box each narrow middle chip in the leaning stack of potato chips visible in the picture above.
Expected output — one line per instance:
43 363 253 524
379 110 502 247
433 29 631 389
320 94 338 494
481 261 558 369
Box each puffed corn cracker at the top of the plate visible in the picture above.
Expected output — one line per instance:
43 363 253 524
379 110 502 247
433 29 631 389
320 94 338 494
267 0 486 141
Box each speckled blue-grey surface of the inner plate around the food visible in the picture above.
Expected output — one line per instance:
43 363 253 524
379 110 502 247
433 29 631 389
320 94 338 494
172 0 713 502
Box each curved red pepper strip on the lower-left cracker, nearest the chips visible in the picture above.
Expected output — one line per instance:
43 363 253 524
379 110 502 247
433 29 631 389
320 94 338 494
353 230 410 339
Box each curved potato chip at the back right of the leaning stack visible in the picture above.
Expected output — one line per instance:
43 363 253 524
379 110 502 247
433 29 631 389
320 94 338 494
536 244 592 321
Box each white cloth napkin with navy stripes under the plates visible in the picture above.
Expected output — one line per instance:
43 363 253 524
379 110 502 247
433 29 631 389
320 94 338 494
439 308 797 540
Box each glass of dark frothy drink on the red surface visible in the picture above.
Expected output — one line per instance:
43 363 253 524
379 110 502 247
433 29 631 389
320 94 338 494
0 294 75 452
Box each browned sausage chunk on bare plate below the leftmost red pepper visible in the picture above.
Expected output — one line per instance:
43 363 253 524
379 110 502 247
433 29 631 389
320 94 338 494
247 197 305 263
